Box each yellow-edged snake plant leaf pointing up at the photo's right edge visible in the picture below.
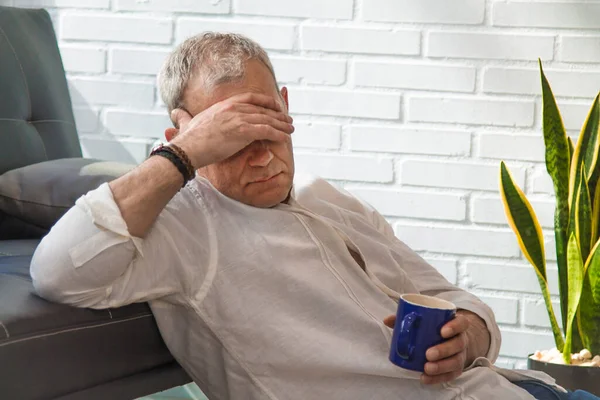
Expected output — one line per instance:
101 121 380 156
569 95 600 206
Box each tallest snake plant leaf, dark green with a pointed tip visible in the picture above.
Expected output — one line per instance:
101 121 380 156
538 60 574 329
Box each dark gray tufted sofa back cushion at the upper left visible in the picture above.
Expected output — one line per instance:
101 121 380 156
0 2 81 173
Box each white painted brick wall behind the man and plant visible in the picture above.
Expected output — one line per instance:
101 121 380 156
19 0 600 366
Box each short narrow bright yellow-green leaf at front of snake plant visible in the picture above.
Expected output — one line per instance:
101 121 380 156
562 232 584 364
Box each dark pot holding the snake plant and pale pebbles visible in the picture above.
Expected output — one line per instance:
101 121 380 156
527 354 600 396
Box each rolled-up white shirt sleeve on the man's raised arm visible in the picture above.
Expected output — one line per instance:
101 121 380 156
31 184 207 308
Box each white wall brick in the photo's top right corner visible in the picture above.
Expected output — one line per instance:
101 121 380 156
492 1 600 29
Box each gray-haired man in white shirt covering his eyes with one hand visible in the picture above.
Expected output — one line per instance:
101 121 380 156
31 33 592 400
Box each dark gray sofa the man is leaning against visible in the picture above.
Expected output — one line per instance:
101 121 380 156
0 7 190 400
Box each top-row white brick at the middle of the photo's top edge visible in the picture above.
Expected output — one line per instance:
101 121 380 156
234 0 354 19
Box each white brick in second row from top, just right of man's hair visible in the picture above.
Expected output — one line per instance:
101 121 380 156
300 25 421 55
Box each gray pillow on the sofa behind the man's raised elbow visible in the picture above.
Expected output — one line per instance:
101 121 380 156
0 158 135 229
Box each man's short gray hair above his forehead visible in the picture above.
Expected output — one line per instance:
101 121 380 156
158 32 277 113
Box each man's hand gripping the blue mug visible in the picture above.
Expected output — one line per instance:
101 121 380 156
383 310 489 384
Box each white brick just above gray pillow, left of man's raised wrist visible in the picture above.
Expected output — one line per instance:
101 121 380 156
80 136 150 164
